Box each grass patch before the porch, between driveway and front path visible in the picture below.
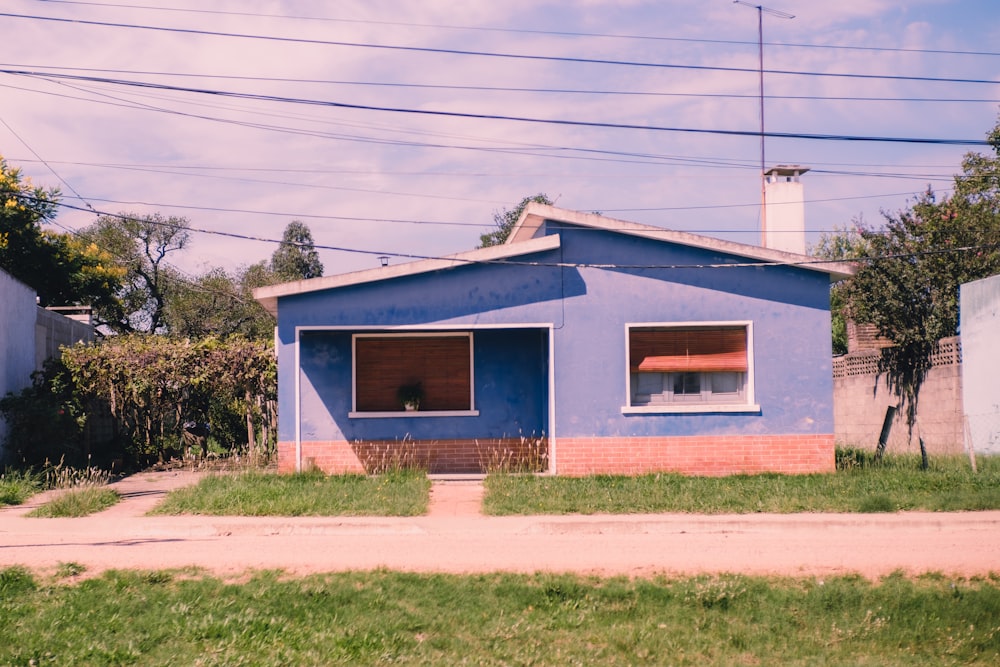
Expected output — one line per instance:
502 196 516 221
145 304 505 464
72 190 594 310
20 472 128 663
150 470 430 516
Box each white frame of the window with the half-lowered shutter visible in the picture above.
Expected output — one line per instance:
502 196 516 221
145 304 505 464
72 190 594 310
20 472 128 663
622 320 760 414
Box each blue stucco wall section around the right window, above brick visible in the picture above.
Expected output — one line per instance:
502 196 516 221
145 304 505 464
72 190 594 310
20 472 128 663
555 228 833 437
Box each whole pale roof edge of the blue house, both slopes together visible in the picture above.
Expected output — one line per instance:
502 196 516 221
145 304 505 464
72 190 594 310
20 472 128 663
253 202 854 317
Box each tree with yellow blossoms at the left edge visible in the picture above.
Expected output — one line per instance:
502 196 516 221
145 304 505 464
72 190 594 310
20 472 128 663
0 157 124 307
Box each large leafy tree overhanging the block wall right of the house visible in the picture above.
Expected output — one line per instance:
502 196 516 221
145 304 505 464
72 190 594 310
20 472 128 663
846 118 1000 433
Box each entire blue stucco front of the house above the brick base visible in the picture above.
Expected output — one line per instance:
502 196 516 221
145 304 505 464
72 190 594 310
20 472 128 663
278 226 833 440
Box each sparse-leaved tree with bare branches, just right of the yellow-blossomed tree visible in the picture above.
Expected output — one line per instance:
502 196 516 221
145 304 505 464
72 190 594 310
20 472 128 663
80 213 190 333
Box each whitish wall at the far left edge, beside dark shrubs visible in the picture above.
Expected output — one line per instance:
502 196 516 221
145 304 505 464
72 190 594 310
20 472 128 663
0 269 38 454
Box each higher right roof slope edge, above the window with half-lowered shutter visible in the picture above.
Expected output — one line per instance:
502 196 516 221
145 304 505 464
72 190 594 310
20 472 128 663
507 202 855 280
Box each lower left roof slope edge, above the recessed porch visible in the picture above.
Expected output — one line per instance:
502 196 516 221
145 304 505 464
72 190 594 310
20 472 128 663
253 235 559 317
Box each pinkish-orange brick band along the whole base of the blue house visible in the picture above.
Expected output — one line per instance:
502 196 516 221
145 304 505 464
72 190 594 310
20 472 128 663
278 433 835 476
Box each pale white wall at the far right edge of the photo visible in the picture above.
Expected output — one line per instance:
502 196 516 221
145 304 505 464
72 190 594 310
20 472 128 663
959 275 1000 454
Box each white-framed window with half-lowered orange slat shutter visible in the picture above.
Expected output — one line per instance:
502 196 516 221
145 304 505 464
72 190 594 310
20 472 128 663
626 323 757 412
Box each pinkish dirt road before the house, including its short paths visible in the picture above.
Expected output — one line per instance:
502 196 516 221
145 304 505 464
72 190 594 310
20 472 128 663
0 471 1000 578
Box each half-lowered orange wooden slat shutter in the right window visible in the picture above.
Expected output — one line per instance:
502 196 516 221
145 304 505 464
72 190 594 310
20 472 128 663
629 327 747 373
